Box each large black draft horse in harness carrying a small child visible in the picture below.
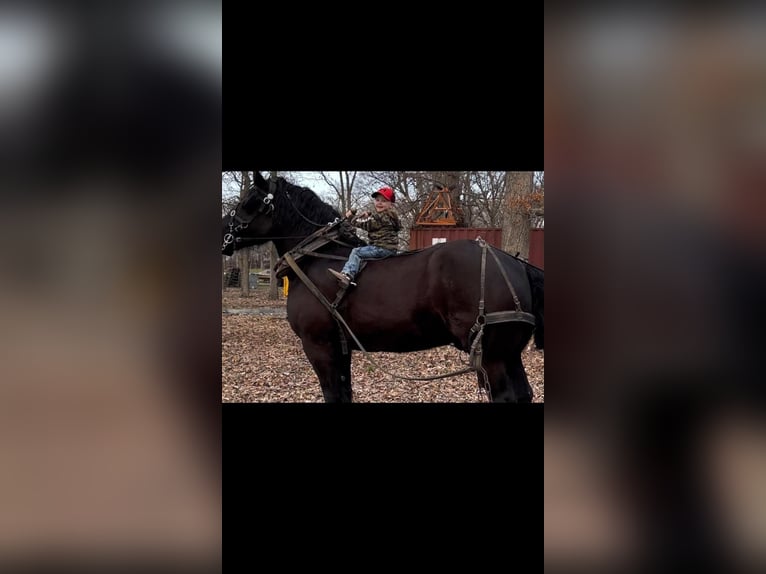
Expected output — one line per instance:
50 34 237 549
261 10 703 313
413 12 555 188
222 172 544 402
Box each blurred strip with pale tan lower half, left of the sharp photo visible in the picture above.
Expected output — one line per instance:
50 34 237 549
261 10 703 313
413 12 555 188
0 1 222 571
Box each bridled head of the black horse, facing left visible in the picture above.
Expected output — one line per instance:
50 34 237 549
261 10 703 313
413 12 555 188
221 171 274 255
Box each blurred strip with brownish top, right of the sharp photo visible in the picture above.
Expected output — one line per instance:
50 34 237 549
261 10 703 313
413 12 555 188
544 6 766 571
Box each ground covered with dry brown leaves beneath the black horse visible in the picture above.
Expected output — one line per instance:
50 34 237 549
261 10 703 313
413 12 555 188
221 288 545 403
